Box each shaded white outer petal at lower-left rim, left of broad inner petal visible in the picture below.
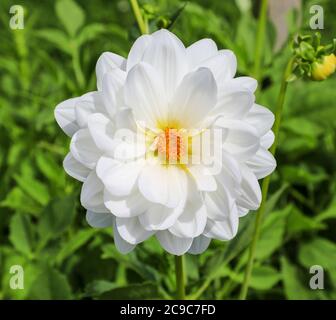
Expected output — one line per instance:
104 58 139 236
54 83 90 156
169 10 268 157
80 171 109 213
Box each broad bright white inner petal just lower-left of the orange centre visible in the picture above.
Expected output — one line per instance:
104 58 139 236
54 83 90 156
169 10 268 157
96 156 143 196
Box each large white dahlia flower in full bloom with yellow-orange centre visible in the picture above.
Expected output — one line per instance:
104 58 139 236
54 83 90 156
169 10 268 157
55 29 276 255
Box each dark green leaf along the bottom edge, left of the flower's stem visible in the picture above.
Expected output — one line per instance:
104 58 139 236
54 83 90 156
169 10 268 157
99 283 162 300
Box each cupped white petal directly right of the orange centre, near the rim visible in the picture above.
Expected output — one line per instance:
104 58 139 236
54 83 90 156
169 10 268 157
216 117 260 161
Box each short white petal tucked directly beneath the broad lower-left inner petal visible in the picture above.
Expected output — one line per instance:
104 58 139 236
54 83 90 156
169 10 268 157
104 189 149 218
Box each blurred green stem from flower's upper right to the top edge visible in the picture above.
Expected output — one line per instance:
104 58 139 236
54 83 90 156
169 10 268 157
253 0 268 81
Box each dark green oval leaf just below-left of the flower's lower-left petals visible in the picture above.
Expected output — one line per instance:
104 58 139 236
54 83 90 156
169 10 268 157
38 196 76 242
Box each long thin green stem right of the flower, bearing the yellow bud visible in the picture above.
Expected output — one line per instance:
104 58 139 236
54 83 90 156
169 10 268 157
239 59 293 300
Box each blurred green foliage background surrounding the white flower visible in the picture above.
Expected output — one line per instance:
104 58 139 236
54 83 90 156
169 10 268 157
0 0 336 299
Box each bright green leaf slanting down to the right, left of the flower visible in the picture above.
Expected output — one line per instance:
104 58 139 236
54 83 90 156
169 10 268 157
14 175 50 206
